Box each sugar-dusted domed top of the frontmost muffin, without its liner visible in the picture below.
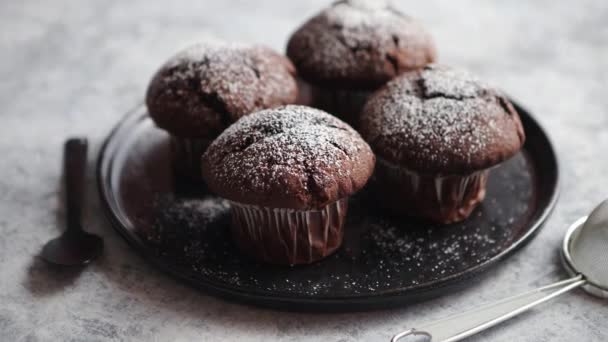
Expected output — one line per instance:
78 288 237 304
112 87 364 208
202 105 375 210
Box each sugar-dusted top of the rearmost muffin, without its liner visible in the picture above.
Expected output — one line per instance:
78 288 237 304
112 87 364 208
288 0 435 86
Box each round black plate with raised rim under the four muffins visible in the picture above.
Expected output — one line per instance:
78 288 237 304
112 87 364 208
98 100 558 311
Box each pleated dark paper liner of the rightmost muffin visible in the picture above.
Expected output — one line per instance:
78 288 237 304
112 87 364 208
374 158 489 224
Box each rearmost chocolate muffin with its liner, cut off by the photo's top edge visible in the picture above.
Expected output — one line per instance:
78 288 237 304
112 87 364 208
287 0 436 127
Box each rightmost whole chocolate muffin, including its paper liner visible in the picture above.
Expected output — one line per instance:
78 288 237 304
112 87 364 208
361 65 525 223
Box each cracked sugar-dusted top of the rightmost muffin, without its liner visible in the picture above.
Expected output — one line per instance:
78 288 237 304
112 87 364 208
360 65 525 174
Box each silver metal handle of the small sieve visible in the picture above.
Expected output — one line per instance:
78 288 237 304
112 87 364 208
391 275 587 342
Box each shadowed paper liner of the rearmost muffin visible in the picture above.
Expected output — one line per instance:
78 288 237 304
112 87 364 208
298 79 373 128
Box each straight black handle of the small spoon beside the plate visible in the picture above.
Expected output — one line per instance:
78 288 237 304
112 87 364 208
63 138 88 232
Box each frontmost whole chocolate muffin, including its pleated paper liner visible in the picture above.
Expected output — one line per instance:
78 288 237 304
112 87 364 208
202 105 375 265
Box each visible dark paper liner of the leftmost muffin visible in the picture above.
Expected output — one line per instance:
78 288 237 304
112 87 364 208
170 136 211 193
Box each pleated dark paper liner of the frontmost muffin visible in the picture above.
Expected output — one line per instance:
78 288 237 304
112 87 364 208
231 198 348 265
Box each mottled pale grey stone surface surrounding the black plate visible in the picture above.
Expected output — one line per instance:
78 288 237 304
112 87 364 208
0 0 608 342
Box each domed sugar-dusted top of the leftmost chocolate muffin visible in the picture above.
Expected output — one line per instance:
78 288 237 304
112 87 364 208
146 42 297 139
